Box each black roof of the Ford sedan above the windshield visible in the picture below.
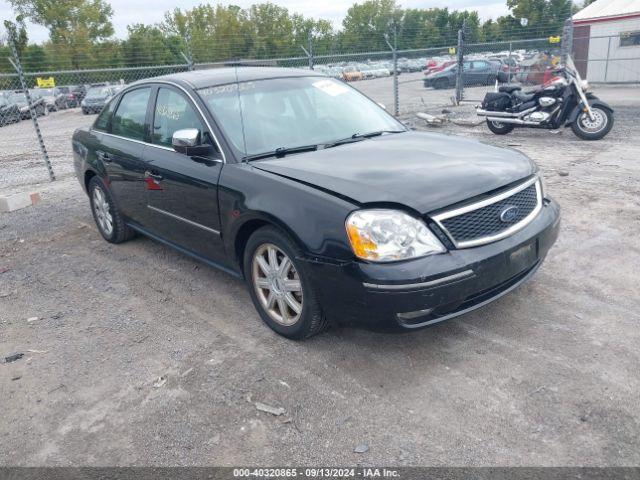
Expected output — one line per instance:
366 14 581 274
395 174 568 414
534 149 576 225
136 66 326 89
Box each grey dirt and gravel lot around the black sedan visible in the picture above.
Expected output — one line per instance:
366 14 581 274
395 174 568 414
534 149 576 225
0 80 640 466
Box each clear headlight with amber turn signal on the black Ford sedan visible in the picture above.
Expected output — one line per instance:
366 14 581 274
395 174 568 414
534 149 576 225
346 209 445 262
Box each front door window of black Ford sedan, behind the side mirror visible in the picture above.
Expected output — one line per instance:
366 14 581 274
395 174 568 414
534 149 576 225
151 87 205 147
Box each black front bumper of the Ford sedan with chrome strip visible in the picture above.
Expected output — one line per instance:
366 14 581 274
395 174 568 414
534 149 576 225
307 199 560 330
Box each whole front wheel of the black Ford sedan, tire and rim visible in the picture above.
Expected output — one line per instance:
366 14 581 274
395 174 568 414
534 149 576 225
243 226 329 340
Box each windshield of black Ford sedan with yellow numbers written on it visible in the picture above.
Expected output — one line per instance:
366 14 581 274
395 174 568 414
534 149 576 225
199 77 405 157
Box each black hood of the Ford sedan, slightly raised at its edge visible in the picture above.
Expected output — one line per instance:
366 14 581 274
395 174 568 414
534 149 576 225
252 132 537 213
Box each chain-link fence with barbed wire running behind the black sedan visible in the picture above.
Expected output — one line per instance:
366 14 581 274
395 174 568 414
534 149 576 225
0 19 640 186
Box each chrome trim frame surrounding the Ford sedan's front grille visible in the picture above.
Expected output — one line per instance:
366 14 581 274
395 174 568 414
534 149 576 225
431 176 542 248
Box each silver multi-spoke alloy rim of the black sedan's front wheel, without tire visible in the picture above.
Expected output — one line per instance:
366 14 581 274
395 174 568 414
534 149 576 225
251 243 303 326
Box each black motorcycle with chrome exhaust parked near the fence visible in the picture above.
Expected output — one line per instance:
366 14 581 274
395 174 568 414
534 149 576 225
476 57 613 140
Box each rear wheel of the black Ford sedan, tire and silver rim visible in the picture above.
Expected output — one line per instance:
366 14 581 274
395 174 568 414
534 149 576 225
88 176 135 243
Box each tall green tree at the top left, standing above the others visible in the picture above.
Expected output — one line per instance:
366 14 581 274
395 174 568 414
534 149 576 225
9 0 113 68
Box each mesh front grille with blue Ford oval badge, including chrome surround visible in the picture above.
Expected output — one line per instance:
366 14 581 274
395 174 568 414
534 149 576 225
434 181 542 248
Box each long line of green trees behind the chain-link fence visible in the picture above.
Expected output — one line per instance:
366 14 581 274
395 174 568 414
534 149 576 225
0 0 576 72
